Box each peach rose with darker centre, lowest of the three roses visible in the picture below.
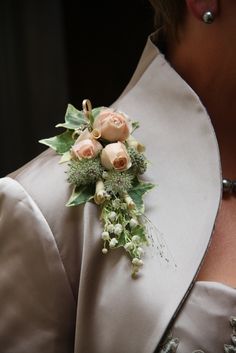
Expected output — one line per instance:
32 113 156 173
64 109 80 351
101 142 131 172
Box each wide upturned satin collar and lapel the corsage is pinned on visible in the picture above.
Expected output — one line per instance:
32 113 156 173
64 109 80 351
75 33 221 353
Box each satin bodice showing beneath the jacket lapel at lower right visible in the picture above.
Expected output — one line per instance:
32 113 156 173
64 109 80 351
165 281 236 353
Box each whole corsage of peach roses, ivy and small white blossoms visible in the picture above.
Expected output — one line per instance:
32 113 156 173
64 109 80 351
39 100 154 276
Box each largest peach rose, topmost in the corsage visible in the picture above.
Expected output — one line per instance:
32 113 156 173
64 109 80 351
93 108 129 142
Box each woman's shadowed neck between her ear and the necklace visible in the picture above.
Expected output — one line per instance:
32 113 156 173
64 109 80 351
167 21 236 179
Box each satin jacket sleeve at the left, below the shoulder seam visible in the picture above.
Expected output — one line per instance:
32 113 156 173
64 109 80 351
0 178 76 353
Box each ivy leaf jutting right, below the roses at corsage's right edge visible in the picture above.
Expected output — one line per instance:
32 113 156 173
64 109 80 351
128 178 155 213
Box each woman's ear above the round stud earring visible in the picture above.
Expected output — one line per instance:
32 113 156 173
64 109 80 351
186 0 218 20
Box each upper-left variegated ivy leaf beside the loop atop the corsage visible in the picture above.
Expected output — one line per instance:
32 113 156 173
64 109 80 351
56 104 88 130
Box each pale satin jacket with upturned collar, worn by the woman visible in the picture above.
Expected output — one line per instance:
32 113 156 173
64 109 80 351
0 39 221 353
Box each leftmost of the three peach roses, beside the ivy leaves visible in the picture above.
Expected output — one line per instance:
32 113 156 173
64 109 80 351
72 139 102 159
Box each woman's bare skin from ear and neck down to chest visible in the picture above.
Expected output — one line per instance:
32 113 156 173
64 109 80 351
167 0 236 288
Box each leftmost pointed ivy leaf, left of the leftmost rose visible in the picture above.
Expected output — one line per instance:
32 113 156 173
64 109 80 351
39 130 75 154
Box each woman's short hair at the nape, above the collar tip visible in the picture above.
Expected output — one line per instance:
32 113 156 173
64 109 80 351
149 0 186 39
